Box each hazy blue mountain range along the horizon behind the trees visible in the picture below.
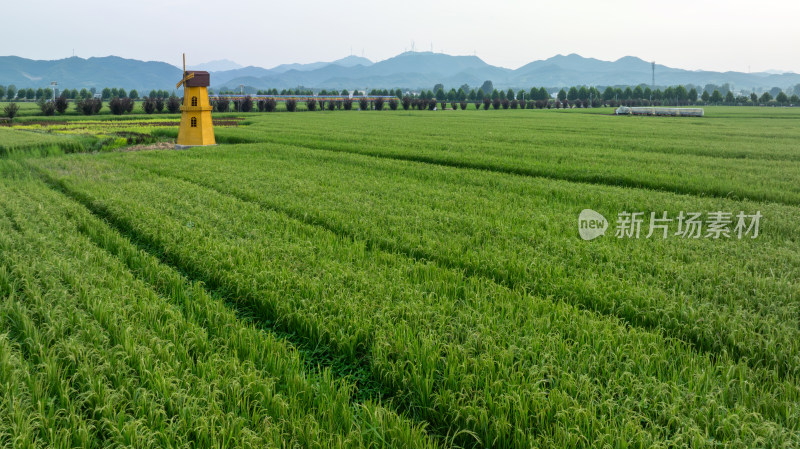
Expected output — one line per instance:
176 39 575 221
0 52 800 92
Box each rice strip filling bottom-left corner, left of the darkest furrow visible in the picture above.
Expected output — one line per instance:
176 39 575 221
0 163 435 447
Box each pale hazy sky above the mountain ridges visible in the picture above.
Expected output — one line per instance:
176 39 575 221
0 0 800 73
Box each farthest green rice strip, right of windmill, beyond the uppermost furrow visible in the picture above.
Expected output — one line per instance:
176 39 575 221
228 113 800 205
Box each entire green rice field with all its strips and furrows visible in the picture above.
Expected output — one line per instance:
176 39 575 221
0 107 800 448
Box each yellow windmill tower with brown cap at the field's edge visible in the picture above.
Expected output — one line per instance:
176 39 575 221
176 54 217 148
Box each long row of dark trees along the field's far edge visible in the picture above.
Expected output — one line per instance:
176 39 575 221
0 80 800 118
